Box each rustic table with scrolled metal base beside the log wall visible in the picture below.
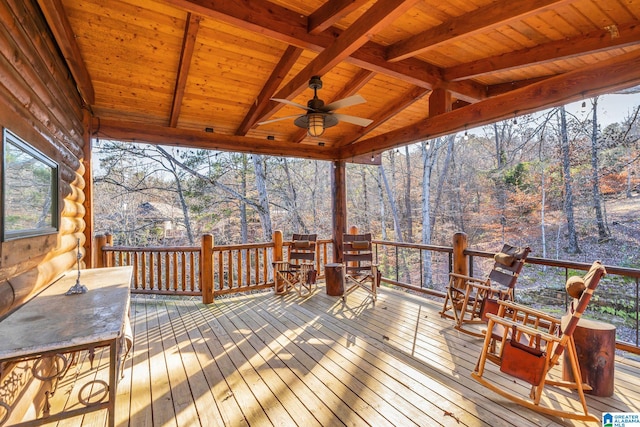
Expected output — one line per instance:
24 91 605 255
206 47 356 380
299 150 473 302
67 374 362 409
0 267 133 426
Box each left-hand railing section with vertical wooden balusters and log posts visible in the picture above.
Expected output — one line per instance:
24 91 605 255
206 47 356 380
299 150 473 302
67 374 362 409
96 232 333 302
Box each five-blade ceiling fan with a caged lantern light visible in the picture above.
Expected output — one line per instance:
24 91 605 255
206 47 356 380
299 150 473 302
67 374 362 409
258 76 373 136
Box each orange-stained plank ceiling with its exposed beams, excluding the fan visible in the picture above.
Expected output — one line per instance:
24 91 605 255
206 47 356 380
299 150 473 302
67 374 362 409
38 0 640 161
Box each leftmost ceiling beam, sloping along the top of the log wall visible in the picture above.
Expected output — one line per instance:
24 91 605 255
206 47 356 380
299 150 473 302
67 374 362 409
38 0 96 105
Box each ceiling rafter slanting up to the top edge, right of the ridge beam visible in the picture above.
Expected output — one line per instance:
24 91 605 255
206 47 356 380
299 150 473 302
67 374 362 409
386 0 569 61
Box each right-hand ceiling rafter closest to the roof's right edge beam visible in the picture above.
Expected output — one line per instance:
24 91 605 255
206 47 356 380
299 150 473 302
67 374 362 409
443 22 640 81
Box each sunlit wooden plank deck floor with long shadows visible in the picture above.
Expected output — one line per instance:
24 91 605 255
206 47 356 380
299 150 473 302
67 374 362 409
46 287 640 427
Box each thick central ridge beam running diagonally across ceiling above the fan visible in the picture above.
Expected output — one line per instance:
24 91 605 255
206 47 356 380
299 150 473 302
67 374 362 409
165 0 486 101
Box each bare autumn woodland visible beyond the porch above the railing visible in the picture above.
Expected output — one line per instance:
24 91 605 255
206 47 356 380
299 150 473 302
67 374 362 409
94 98 640 268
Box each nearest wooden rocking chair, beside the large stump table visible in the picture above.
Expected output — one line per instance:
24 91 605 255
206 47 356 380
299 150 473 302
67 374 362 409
471 261 606 421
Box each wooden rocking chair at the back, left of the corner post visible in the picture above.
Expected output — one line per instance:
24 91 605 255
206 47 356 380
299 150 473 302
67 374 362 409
273 234 317 297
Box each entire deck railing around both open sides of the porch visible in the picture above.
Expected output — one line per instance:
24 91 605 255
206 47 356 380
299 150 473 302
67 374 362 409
97 232 640 353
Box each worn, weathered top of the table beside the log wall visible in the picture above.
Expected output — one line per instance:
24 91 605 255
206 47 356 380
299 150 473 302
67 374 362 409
0 267 133 360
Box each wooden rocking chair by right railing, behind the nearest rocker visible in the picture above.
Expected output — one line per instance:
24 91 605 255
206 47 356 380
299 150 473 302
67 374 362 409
440 244 531 337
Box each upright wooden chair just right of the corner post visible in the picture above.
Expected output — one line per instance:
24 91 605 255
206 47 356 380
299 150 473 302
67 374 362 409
342 233 381 303
